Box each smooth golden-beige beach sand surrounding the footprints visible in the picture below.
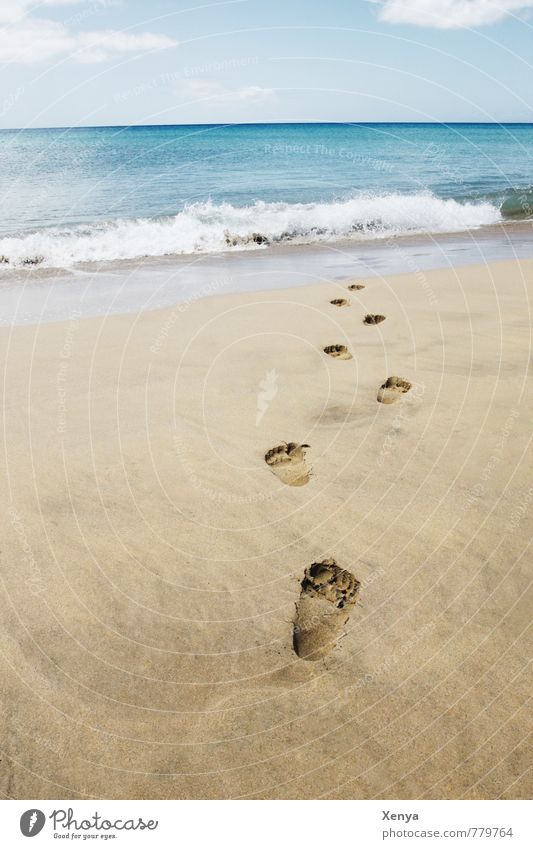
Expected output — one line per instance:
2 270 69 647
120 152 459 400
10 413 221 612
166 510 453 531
0 261 533 799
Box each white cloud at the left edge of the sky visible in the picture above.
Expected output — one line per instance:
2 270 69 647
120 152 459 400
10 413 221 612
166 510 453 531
0 0 177 63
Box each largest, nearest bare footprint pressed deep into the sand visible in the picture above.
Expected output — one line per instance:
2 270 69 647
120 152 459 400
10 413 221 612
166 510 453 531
293 560 361 660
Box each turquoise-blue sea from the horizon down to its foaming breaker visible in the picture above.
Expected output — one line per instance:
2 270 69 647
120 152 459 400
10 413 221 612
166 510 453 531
0 124 533 270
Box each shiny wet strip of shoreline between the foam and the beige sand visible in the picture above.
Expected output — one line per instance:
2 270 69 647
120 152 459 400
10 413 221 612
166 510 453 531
0 222 533 326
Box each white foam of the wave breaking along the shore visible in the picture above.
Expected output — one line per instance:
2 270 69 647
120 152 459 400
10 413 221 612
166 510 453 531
0 193 501 270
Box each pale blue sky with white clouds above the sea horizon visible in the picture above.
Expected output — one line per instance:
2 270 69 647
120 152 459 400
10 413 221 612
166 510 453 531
0 0 533 128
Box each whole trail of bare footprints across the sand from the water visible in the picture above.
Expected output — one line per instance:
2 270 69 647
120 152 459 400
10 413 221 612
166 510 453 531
265 283 412 661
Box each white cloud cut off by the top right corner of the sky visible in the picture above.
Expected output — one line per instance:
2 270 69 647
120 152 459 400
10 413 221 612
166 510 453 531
379 0 533 29
